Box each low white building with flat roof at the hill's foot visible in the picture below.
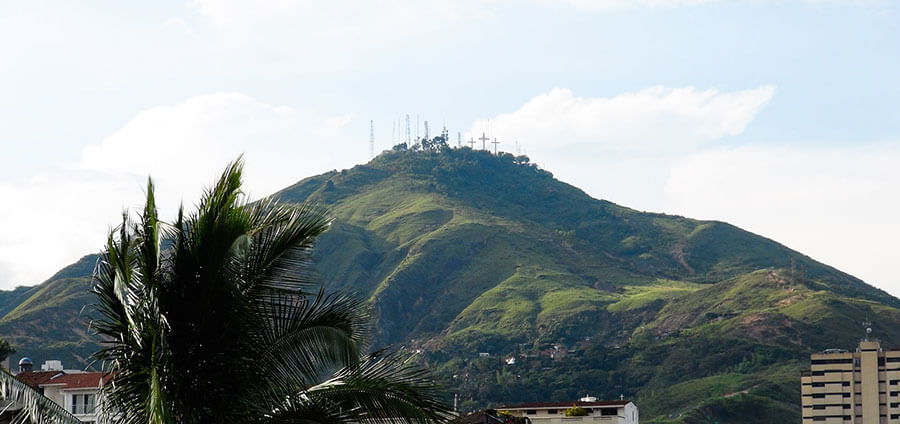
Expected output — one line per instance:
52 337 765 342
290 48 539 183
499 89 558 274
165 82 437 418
497 397 640 424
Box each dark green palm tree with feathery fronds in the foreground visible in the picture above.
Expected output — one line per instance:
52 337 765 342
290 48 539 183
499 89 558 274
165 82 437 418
92 159 449 424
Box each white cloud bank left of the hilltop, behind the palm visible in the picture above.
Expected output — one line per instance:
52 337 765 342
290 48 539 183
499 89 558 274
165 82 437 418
0 93 358 288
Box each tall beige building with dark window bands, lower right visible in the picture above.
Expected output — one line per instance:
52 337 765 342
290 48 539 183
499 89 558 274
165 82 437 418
800 339 900 424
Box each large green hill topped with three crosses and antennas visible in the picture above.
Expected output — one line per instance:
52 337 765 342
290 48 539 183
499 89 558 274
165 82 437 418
0 148 900 423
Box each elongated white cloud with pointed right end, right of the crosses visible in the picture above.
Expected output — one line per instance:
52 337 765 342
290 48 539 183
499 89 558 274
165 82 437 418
467 86 775 153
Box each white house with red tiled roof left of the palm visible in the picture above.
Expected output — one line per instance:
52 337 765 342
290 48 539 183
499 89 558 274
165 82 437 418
16 358 109 424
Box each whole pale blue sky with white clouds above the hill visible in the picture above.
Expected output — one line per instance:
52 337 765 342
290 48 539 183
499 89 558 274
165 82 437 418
0 0 900 295
